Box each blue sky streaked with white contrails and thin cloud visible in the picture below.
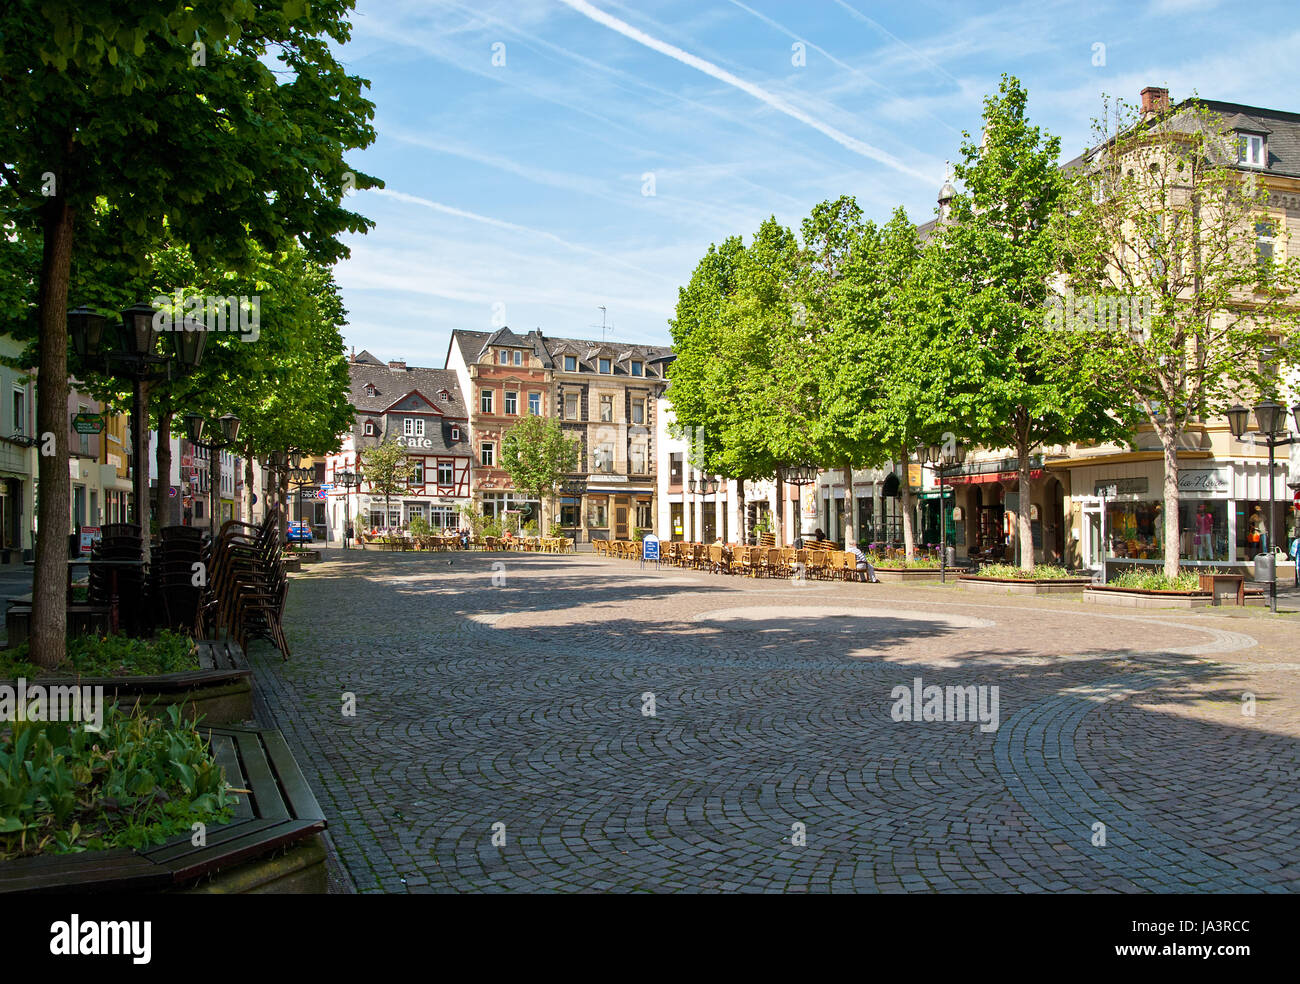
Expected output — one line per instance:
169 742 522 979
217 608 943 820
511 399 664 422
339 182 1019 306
337 0 1300 367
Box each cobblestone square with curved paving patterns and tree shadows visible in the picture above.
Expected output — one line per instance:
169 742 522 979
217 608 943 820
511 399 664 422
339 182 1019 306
245 550 1300 892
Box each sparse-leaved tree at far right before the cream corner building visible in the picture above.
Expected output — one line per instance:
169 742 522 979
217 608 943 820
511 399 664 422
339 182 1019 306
1054 94 1300 580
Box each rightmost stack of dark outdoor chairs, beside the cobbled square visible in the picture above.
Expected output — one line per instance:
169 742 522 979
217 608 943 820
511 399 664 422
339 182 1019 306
195 510 289 659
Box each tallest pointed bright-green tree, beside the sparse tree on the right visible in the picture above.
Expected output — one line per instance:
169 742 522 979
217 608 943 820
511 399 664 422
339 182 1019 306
931 75 1128 571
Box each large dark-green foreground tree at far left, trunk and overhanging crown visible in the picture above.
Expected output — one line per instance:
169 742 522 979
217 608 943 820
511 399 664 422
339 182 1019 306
0 0 377 666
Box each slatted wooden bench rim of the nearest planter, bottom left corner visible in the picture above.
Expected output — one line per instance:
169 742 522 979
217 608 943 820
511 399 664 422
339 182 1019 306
0 728 329 894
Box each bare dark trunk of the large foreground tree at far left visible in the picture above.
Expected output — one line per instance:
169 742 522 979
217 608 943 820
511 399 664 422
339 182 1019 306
31 192 74 667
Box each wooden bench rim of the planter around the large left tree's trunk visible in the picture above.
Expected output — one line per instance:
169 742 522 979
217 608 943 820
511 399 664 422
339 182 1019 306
5 640 252 724
